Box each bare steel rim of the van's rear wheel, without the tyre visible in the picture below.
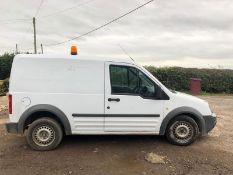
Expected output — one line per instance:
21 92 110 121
32 125 55 146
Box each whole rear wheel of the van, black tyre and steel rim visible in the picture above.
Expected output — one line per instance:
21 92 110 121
26 118 63 151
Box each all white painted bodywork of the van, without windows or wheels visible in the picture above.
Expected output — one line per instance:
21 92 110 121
9 55 211 134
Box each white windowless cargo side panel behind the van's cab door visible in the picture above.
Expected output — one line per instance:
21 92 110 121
10 57 104 133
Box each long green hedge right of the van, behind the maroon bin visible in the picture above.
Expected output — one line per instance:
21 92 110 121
146 66 233 93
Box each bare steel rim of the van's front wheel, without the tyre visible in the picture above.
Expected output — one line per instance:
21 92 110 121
173 121 193 141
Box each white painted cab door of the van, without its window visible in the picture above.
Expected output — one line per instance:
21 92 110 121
104 62 164 133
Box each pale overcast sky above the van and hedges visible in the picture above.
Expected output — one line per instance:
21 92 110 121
0 0 233 69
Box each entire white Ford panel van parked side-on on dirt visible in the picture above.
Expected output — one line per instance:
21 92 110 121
6 55 216 150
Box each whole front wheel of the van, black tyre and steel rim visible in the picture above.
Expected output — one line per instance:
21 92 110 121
166 115 199 146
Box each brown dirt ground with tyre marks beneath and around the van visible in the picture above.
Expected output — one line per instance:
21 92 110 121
0 96 233 175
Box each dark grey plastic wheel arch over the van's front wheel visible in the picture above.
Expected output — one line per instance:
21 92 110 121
159 106 205 135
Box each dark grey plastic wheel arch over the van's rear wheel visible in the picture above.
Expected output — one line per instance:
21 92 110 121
18 104 71 135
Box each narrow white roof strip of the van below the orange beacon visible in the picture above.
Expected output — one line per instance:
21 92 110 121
15 54 135 64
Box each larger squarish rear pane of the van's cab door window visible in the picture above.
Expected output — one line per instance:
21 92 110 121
110 65 139 94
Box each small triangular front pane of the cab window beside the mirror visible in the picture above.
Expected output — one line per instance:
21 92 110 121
139 71 158 98
